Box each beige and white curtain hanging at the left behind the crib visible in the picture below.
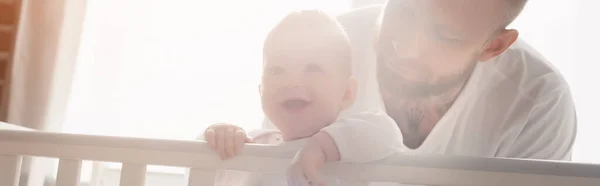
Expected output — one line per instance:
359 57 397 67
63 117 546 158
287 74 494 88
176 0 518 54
8 0 85 185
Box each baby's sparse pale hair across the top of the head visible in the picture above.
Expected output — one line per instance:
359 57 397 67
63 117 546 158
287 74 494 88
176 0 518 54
263 10 352 75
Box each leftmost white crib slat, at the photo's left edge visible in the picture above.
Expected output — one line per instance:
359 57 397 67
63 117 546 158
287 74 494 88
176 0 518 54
0 155 23 186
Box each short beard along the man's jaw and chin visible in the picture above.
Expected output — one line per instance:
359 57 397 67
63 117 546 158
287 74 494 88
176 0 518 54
377 55 476 100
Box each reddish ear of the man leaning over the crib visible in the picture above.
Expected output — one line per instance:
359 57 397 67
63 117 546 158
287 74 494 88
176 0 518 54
477 29 519 62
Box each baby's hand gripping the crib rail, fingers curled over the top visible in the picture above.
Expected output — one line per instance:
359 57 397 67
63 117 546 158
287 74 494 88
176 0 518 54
204 123 252 160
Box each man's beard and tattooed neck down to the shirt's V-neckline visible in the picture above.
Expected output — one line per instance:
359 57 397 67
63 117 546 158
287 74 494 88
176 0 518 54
377 52 477 149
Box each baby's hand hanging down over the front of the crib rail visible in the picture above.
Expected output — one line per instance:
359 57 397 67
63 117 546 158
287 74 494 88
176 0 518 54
287 132 340 186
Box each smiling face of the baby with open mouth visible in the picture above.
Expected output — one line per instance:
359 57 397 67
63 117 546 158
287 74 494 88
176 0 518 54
260 50 356 140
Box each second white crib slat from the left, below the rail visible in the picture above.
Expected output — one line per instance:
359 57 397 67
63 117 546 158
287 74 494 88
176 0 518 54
56 159 81 186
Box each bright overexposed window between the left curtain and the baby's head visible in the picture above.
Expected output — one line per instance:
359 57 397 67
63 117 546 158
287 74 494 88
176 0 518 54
64 0 351 181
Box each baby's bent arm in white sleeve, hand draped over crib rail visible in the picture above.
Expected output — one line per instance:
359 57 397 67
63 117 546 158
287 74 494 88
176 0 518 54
288 112 402 185
